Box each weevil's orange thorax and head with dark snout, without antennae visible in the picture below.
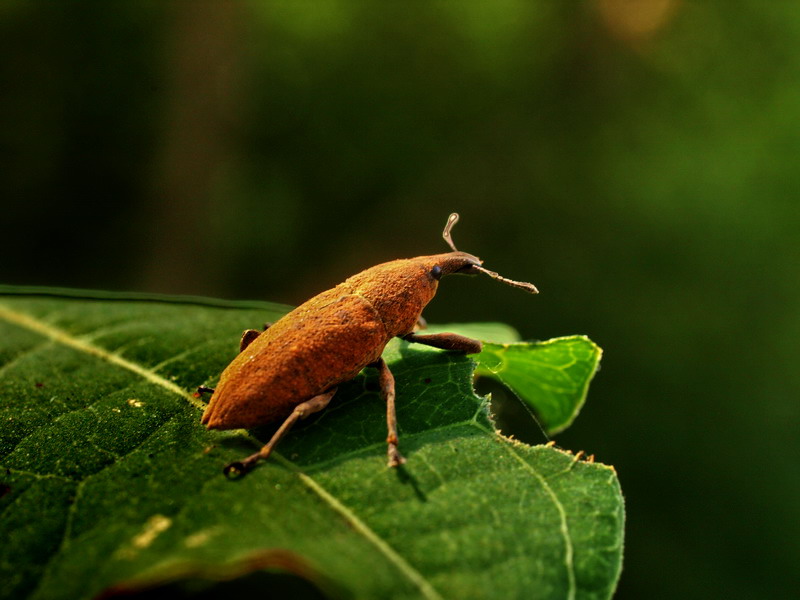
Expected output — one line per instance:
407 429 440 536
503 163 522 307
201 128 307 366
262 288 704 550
345 252 480 337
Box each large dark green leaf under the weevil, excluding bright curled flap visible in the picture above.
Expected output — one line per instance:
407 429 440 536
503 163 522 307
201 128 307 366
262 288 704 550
0 288 624 599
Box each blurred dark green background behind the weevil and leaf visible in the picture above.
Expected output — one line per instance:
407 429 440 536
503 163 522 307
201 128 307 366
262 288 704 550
0 0 800 599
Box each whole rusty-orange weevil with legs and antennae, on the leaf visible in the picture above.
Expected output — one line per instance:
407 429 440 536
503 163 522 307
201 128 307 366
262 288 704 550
198 213 538 476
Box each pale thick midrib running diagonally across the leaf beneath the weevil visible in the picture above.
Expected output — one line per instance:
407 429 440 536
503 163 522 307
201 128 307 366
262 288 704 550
0 303 443 600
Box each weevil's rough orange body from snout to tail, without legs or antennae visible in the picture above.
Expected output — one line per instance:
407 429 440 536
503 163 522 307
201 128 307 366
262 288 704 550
202 252 480 429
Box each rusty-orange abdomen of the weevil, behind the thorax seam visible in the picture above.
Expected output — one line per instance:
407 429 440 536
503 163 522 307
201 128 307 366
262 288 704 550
202 287 390 429
